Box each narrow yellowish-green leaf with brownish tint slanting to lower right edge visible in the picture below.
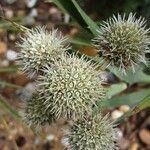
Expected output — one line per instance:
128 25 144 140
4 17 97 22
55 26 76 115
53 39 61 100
116 95 150 123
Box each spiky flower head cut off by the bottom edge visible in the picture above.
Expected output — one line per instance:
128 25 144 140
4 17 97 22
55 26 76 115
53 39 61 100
64 114 117 150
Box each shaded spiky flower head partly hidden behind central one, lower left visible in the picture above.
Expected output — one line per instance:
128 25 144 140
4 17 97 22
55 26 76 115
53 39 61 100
21 94 53 128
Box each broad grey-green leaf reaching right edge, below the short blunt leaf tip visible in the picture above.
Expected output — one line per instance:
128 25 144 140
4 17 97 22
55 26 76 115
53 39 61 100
97 89 150 109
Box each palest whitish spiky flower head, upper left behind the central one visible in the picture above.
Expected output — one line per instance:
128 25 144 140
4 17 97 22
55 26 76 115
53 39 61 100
18 27 68 77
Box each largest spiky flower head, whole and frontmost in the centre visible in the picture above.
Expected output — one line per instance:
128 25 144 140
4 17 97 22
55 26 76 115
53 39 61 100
38 55 105 118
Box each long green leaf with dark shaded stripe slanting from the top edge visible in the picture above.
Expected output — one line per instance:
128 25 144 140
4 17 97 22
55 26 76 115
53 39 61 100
47 0 99 35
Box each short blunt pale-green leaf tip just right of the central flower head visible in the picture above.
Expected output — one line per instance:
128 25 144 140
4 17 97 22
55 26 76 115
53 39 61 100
106 83 127 99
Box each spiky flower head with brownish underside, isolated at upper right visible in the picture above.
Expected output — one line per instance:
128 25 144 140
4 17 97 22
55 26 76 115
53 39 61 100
94 13 150 73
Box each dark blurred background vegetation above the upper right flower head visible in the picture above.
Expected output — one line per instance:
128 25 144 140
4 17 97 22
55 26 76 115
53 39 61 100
77 0 150 26
